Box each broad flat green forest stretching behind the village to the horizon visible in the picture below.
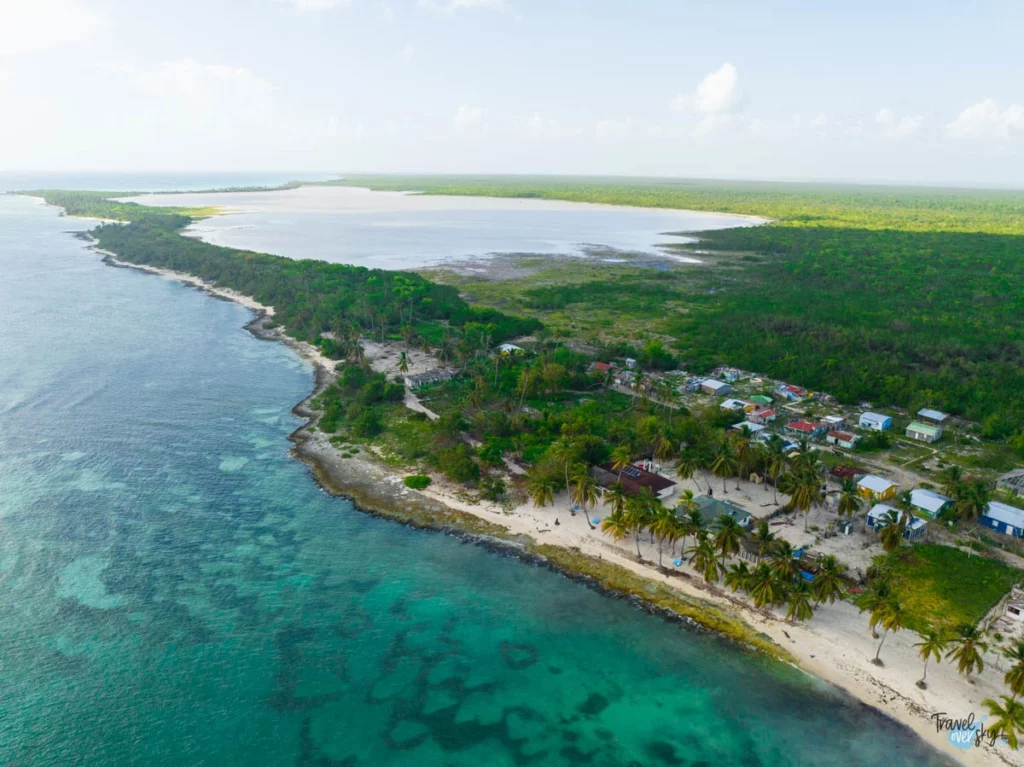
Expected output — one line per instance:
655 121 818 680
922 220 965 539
349 177 1024 436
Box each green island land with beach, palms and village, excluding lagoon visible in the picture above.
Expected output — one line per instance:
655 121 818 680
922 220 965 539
18 178 1024 760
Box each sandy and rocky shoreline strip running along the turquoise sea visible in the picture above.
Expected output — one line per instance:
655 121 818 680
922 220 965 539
83 243 1024 765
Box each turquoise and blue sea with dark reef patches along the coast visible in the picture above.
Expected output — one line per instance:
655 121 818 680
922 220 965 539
0 197 941 765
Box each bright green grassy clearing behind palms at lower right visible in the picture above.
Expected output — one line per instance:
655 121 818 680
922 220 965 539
885 544 1024 631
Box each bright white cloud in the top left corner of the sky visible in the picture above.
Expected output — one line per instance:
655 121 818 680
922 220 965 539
0 0 100 56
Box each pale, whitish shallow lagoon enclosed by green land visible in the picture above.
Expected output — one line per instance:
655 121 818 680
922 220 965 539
128 186 760 269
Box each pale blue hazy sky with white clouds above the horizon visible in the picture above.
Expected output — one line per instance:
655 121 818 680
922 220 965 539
0 0 1024 187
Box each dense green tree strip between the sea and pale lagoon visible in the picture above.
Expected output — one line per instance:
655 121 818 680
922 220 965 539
19 190 540 358
